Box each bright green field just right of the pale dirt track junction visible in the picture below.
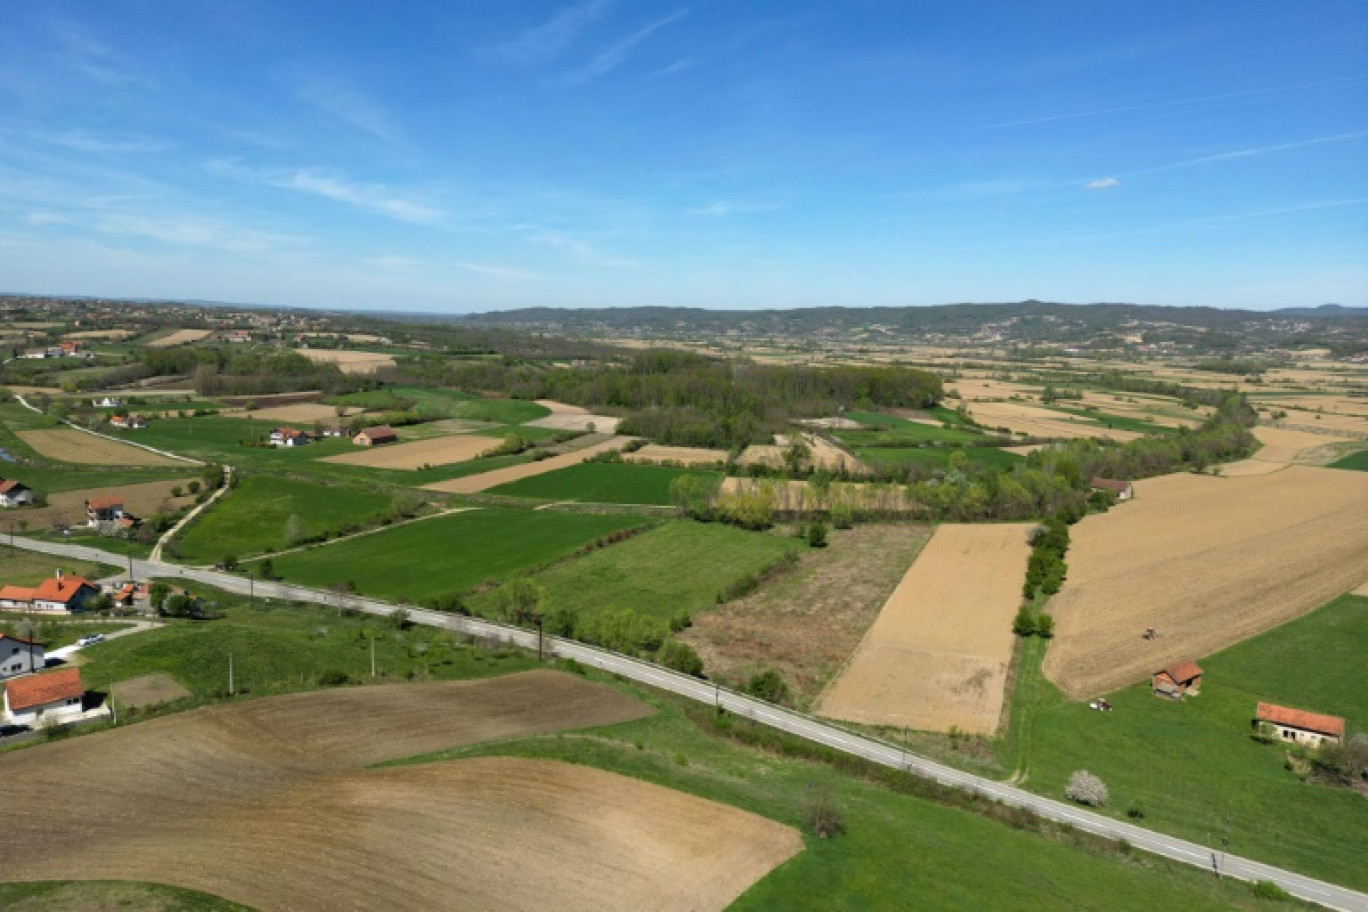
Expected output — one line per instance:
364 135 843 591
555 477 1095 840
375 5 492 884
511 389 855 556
176 474 394 563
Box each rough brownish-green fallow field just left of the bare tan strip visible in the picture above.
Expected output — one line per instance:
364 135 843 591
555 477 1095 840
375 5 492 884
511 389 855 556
680 522 930 704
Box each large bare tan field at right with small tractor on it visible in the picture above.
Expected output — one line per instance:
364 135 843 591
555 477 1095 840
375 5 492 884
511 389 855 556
1045 465 1368 699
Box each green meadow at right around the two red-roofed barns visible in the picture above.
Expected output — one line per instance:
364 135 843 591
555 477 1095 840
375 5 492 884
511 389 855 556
1004 596 1368 890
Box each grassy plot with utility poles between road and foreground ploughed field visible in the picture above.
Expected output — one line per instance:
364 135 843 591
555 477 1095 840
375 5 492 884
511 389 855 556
70 585 536 715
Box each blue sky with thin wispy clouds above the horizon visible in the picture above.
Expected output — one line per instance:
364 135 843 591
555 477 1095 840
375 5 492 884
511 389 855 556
0 0 1368 312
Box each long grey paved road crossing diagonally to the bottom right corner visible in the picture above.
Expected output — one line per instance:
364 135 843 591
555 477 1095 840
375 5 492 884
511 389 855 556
14 536 1368 912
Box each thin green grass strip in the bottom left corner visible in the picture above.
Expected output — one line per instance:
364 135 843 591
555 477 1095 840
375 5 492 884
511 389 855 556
0 881 252 912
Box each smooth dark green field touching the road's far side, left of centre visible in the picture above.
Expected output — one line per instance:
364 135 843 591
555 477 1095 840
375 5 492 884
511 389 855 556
275 509 642 603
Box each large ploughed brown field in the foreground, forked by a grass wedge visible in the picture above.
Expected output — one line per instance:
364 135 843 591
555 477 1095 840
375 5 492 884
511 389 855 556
0 671 803 912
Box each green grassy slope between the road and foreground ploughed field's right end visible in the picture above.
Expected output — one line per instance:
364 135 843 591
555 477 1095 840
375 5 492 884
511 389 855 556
391 680 1293 912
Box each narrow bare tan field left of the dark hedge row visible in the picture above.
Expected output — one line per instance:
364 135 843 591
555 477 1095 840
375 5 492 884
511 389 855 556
815 524 1030 734
